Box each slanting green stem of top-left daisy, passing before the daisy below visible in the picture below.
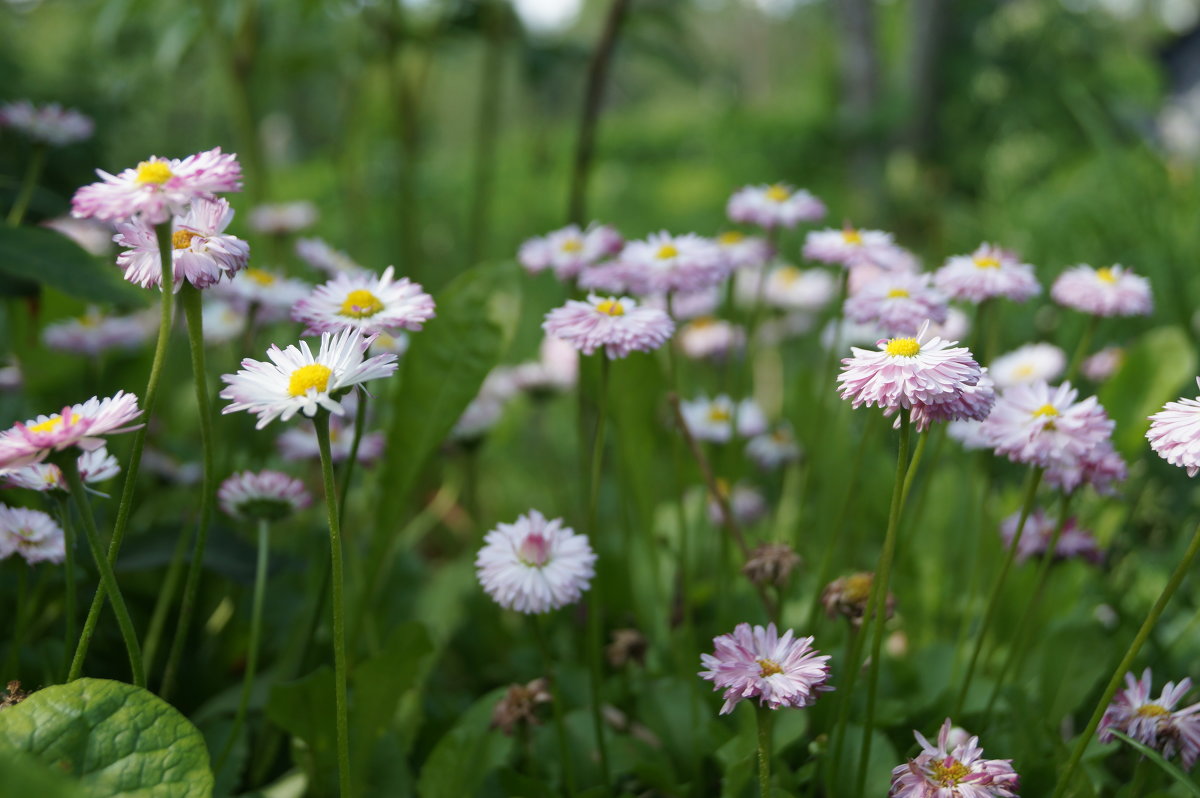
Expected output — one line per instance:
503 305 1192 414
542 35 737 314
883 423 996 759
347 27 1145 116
68 222 175 678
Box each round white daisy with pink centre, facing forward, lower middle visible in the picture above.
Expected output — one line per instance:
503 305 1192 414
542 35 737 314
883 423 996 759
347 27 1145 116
475 510 596 614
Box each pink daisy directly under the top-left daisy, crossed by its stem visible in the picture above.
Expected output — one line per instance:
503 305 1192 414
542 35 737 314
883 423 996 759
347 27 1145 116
113 198 250 292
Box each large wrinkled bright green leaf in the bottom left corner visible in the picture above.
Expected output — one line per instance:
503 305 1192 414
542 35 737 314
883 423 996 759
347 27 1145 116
0 679 212 798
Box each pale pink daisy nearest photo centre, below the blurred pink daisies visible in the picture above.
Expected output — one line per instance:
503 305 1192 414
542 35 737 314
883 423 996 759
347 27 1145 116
541 294 674 360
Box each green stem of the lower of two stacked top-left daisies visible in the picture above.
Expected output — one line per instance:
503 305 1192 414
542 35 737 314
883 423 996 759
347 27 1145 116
158 282 216 700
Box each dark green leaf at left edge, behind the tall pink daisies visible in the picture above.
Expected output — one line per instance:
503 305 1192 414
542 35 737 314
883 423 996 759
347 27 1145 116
0 227 148 307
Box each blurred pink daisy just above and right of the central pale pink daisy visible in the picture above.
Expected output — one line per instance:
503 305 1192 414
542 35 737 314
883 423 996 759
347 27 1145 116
614 230 730 294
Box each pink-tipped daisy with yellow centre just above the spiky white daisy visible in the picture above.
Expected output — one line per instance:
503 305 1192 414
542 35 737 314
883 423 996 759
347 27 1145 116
292 266 433 335
